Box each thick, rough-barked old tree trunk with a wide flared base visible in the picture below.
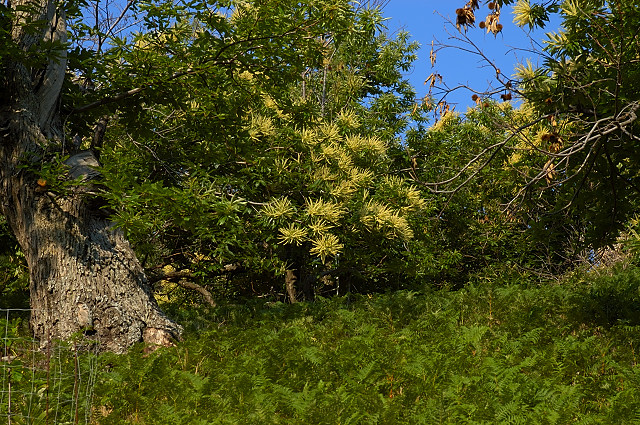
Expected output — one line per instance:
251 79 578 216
0 0 181 352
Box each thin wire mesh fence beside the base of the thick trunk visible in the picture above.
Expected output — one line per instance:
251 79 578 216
0 309 98 425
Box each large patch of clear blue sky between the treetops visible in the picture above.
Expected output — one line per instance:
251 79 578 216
383 0 559 112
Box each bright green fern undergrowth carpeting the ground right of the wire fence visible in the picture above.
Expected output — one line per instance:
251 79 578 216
89 269 640 425
